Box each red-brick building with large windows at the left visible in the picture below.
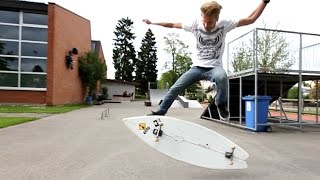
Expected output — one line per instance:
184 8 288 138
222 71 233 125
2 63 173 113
0 0 105 105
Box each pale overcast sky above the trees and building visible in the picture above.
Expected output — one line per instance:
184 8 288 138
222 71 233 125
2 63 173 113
32 0 320 79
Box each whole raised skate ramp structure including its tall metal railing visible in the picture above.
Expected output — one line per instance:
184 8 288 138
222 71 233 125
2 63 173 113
201 28 320 128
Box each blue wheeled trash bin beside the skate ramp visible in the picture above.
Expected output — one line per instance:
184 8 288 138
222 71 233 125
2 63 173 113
242 96 271 132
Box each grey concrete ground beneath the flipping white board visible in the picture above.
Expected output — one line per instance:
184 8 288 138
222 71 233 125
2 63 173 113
0 101 320 180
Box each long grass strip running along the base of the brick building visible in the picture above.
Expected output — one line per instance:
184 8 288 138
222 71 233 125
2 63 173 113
0 104 88 114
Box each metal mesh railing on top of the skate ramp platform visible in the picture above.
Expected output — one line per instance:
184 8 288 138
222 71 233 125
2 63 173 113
227 28 320 74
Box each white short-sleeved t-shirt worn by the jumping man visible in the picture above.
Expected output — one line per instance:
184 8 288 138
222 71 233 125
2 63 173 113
182 19 239 67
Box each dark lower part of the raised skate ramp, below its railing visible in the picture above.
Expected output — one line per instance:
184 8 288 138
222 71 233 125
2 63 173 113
201 73 320 131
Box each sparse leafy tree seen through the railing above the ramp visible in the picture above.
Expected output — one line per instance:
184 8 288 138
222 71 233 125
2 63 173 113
231 30 294 72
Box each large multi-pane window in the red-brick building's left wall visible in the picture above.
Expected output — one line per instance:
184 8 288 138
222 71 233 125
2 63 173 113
0 10 48 90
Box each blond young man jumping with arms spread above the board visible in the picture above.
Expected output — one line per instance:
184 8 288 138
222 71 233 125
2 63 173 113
143 0 270 120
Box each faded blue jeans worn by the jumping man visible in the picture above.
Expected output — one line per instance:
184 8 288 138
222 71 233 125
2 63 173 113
157 66 228 115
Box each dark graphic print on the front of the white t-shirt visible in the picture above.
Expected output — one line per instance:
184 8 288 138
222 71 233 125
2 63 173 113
196 26 224 60
